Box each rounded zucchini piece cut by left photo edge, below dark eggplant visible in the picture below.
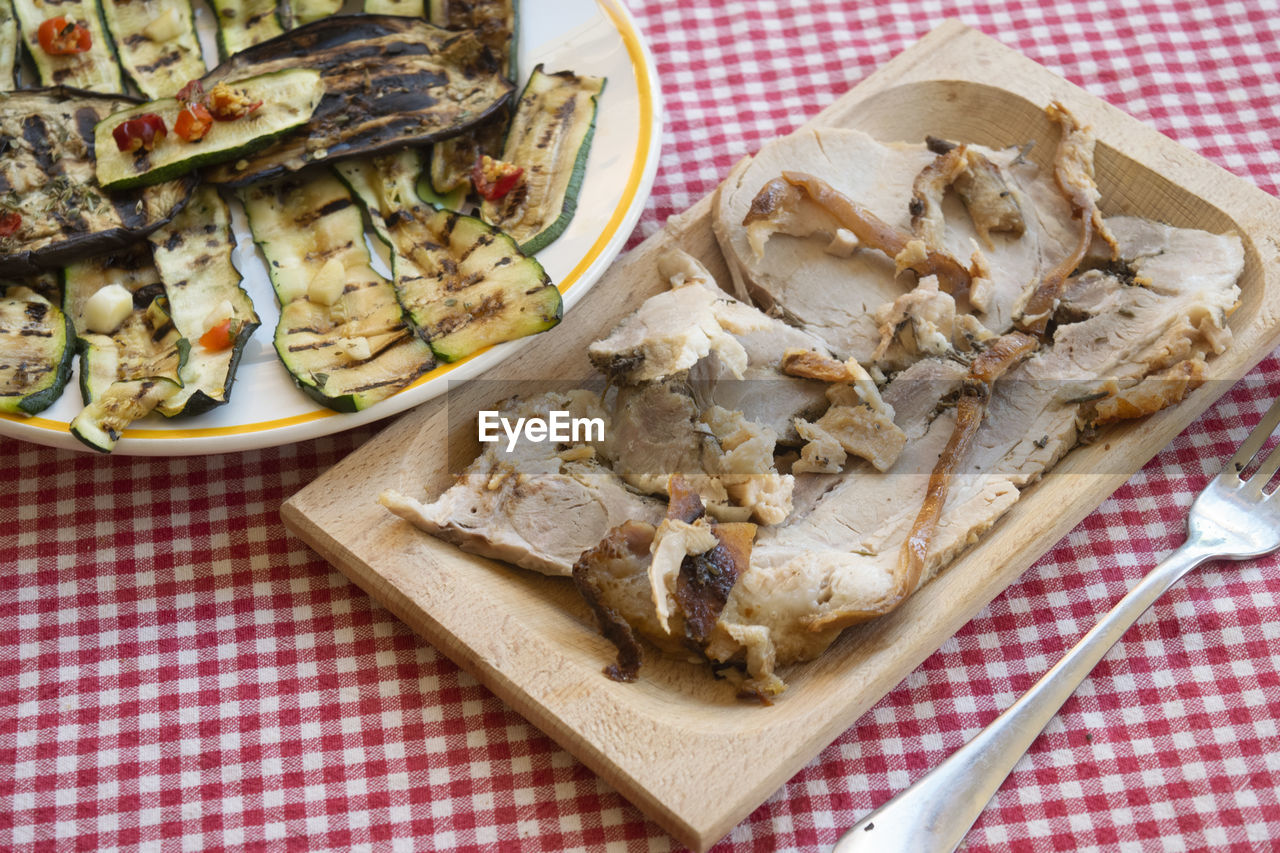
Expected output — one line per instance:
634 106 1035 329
0 277 76 415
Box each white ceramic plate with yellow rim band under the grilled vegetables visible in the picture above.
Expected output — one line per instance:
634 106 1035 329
0 0 662 456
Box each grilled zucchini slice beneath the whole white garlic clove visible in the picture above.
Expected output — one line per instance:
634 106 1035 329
63 242 189 453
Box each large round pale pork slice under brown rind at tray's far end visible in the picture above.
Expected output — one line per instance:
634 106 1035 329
712 128 1075 362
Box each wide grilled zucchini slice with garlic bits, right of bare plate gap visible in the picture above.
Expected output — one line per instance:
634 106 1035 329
241 172 435 411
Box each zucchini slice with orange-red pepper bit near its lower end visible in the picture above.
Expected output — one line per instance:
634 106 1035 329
151 186 259 418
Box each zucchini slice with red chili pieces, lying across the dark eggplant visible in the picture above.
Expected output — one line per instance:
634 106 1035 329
93 68 324 190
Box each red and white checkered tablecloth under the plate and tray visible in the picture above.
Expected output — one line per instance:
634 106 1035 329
0 0 1280 850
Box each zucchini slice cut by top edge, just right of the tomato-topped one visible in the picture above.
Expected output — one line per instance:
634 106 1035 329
100 0 206 99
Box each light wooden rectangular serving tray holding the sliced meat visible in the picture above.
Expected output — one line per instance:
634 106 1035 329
283 22 1280 850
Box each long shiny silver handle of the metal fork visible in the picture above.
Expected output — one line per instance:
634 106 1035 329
833 542 1220 853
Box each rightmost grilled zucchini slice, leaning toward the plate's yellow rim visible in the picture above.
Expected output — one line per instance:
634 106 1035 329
480 65 604 255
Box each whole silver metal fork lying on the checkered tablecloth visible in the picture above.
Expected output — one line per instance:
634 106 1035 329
833 400 1280 853
